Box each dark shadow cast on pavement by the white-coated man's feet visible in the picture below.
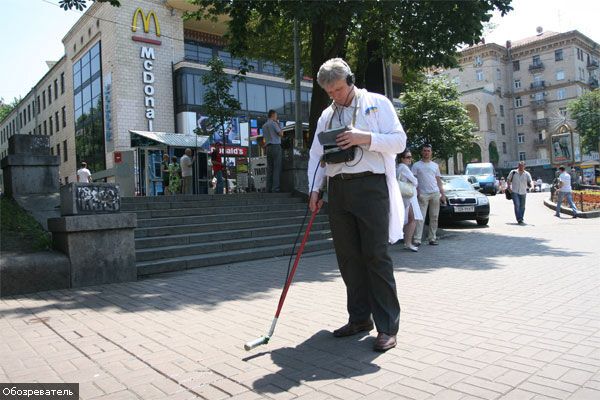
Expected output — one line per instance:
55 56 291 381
252 330 381 394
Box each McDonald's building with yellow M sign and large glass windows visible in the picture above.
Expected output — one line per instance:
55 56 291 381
0 0 312 195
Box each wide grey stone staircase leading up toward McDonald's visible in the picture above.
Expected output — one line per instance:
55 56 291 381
121 193 333 277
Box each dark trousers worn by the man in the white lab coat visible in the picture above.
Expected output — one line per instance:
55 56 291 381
328 175 400 335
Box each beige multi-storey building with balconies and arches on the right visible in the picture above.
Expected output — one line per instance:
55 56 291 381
441 28 600 177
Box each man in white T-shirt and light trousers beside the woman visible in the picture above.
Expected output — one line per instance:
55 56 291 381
409 144 446 246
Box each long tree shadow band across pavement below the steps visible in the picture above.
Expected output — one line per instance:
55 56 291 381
0 216 585 318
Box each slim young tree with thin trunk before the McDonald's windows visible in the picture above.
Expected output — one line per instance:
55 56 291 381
195 57 243 193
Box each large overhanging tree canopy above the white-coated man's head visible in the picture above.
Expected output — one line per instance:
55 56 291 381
187 0 512 144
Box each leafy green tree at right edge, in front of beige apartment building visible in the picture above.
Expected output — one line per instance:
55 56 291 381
567 89 600 151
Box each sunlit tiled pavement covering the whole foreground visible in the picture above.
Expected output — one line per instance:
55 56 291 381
0 194 600 400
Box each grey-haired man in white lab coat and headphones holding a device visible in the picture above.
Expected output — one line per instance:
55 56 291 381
308 58 406 351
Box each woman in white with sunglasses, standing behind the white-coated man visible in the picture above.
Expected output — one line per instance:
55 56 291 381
396 150 423 252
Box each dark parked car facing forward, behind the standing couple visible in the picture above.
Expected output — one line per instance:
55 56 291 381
440 175 490 225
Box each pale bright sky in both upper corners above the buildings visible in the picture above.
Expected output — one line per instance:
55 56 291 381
0 0 600 102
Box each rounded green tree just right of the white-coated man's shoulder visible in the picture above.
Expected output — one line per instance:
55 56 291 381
398 78 476 160
